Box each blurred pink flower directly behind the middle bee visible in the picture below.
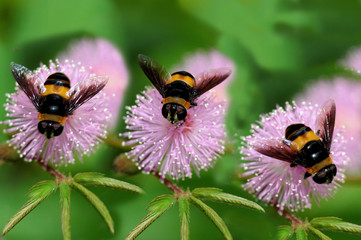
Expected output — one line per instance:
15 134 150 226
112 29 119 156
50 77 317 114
173 50 235 106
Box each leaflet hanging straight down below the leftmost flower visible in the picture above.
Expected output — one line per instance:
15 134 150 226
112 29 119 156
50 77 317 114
59 182 71 240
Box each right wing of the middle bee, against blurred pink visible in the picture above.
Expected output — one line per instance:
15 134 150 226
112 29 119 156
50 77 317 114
191 68 232 100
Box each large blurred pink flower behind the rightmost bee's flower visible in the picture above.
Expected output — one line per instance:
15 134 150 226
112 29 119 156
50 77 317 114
296 78 361 174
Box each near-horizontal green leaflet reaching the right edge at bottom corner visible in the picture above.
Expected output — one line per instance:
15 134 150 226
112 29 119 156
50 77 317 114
310 217 361 234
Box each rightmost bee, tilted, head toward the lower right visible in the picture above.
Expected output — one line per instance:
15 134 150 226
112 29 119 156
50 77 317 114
255 99 337 184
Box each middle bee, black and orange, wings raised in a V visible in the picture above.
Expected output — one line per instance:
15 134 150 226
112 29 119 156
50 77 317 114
138 54 231 124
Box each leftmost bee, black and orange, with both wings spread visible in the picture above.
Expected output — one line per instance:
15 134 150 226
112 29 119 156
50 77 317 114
10 63 107 139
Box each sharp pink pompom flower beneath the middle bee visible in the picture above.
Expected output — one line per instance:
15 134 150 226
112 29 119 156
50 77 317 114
122 88 225 179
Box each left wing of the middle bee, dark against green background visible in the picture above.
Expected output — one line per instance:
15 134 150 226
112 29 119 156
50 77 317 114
138 54 171 97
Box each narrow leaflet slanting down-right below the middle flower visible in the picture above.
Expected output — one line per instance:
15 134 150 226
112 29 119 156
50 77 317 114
190 196 233 240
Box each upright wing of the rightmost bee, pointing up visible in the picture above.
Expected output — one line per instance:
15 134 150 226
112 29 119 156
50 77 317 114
316 99 336 151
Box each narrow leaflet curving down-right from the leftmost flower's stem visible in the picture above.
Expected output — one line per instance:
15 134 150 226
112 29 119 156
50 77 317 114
72 181 114 233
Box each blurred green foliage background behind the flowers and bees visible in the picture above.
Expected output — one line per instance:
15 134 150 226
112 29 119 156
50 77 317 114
0 0 361 240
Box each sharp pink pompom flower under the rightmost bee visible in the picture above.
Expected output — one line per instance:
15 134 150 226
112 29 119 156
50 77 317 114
241 100 348 214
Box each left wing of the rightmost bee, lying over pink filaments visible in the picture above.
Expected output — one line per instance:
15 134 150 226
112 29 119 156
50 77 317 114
253 138 297 163
